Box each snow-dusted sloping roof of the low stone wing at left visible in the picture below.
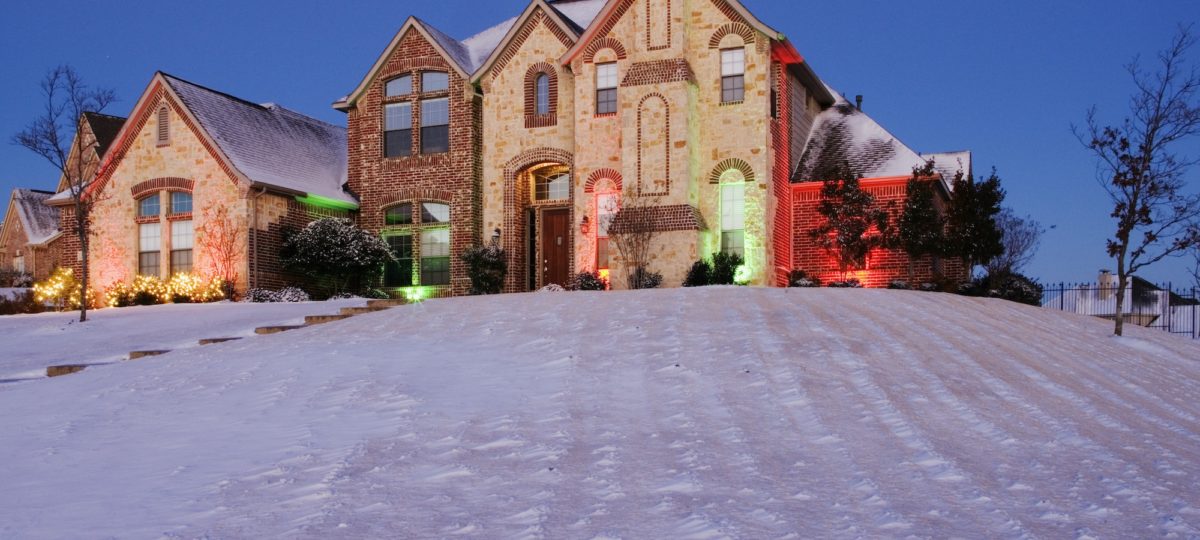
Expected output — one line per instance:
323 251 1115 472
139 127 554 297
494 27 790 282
163 73 358 204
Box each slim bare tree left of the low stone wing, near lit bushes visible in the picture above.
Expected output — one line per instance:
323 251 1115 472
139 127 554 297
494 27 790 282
12 65 116 323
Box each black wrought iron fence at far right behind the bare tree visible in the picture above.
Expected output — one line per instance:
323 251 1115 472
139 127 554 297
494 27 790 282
1042 277 1200 340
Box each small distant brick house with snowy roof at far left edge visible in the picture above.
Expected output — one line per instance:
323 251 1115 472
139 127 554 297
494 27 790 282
0 188 60 280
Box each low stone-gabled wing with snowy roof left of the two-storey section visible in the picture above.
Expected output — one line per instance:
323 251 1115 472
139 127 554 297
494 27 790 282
52 72 358 295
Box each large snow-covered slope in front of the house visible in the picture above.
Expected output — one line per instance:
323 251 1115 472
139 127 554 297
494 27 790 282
0 288 1200 539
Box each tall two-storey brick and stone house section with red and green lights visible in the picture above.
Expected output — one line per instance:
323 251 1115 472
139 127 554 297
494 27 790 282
334 0 971 293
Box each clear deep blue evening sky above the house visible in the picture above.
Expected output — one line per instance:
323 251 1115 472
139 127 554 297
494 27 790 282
0 0 1200 283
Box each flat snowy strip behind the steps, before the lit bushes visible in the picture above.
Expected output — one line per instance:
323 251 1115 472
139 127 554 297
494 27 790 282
0 299 366 380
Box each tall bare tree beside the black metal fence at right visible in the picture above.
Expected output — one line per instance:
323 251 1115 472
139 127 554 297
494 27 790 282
1072 26 1200 336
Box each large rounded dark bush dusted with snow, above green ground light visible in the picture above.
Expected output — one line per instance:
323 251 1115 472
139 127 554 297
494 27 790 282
280 217 395 294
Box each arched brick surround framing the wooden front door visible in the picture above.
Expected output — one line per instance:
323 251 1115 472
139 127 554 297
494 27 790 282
502 146 575 293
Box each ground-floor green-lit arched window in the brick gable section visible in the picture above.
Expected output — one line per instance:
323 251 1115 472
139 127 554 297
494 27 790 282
383 202 450 287
